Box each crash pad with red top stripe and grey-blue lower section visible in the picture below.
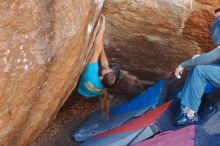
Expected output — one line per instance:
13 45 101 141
80 101 172 146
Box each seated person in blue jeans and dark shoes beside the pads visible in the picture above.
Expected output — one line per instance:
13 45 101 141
175 8 220 126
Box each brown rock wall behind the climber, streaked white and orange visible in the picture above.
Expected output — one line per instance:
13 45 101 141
104 0 220 80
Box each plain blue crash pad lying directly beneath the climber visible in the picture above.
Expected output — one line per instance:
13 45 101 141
73 80 164 142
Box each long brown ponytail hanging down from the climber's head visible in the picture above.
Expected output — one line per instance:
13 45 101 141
99 88 110 119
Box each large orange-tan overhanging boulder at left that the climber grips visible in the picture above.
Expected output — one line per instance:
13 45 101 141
0 0 103 146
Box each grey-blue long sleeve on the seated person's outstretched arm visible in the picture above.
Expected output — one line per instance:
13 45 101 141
180 48 220 68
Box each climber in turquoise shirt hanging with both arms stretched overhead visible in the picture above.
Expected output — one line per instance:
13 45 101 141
78 16 120 118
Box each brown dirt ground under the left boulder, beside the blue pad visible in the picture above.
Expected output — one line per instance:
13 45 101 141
30 90 127 146
